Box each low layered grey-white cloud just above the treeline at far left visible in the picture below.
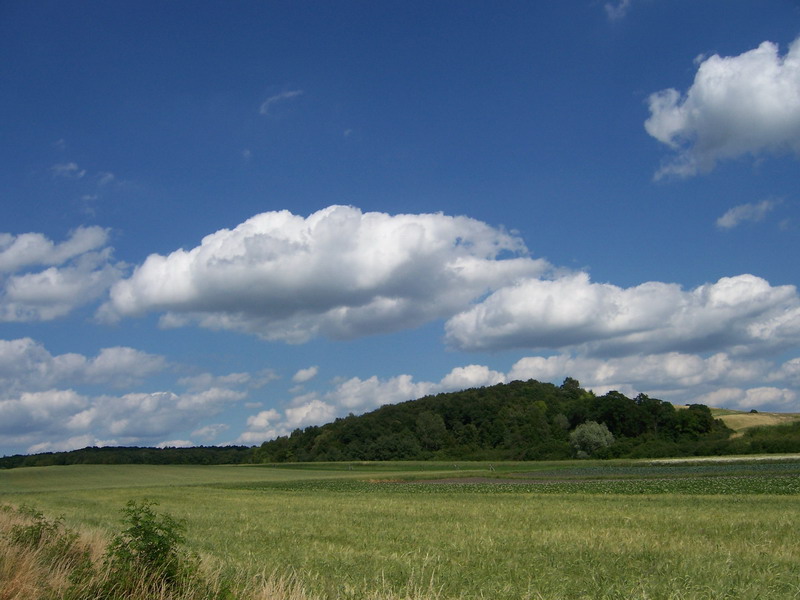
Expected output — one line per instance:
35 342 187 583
0 338 255 452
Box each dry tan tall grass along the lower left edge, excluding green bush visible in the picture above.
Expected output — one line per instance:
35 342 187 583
0 505 438 600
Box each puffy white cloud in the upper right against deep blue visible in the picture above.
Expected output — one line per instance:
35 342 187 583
645 38 800 177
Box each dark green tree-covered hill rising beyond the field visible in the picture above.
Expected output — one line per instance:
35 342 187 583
255 378 744 463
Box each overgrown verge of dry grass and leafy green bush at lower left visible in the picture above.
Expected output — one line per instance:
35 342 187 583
0 501 440 600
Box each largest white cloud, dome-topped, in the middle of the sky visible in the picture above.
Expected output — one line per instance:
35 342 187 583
102 206 547 343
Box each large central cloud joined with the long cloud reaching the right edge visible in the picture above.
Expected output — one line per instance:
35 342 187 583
56 206 800 366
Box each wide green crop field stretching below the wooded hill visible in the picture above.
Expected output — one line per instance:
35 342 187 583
0 456 800 599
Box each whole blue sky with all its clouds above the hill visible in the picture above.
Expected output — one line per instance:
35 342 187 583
0 0 800 454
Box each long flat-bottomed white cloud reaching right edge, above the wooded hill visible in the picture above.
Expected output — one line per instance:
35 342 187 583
446 273 800 356
